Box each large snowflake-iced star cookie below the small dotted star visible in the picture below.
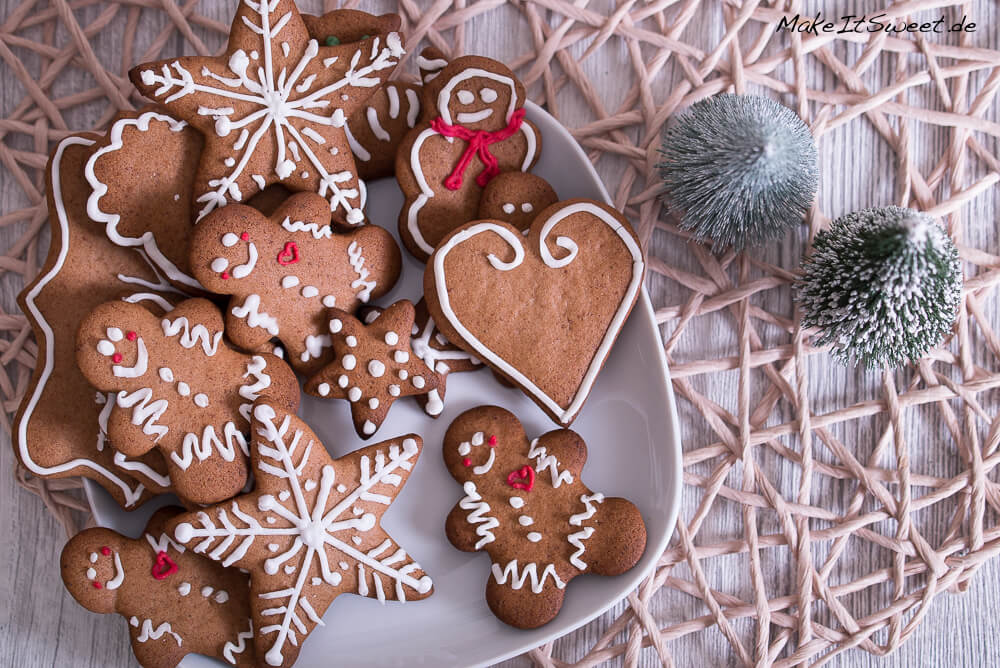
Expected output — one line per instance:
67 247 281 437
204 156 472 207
173 398 433 666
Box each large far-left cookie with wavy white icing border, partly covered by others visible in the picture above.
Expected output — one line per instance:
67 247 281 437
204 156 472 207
13 133 184 508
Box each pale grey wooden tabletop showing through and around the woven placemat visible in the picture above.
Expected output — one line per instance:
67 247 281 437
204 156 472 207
0 0 1000 668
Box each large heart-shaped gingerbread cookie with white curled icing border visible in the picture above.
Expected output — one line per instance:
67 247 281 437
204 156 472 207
424 200 645 425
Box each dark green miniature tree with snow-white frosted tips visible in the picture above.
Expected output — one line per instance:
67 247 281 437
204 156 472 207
797 206 962 369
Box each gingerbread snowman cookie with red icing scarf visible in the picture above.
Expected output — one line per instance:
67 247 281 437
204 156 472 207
396 56 541 260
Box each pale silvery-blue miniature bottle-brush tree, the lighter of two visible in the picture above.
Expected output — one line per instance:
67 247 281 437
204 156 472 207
657 95 819 250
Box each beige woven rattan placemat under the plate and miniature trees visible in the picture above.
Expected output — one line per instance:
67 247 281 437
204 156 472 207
0 0 1000 666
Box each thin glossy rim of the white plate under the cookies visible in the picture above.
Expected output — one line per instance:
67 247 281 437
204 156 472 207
83 100 683 668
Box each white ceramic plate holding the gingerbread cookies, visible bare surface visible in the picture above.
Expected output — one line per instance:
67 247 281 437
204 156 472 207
84 103 681 668
